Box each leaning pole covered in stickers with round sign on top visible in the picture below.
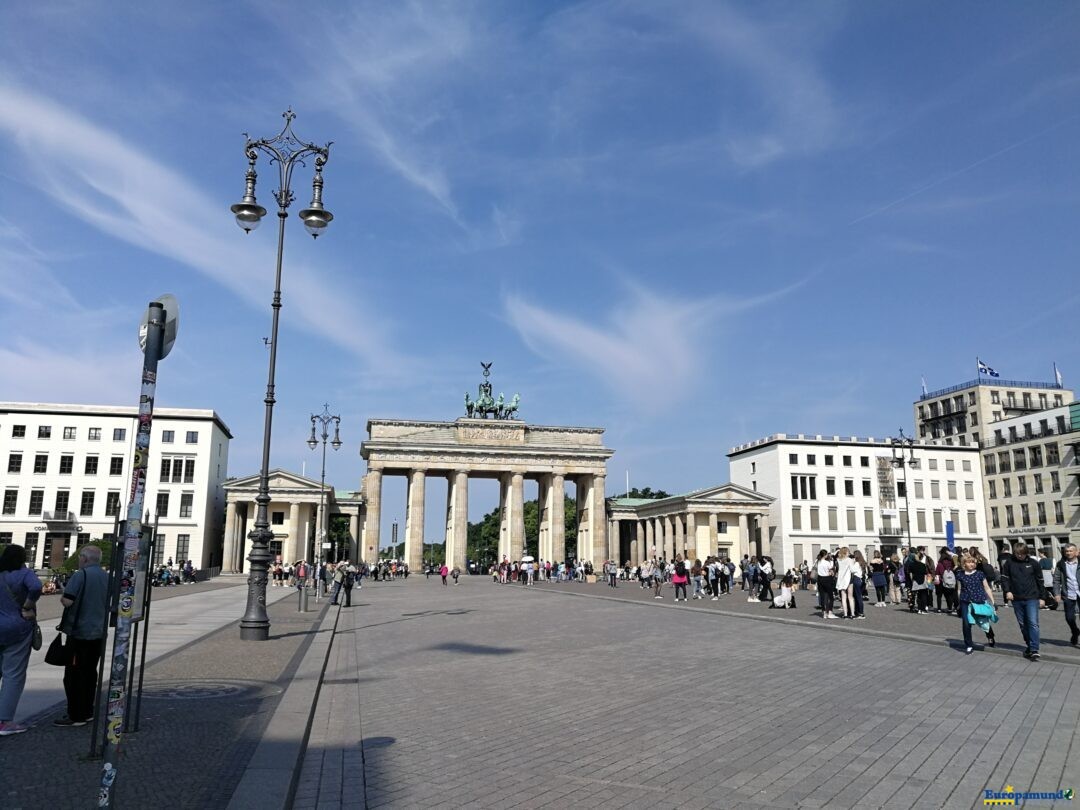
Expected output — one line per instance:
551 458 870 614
97 301 165 807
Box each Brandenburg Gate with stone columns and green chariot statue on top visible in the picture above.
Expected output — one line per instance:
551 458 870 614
360 364 618 571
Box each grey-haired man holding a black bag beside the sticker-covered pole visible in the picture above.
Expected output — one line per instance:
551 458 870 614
53 545 109 727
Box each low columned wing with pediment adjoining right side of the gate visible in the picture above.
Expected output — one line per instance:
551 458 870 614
608 484 773 565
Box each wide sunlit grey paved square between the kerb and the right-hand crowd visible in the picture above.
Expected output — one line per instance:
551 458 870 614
295 578 1080 810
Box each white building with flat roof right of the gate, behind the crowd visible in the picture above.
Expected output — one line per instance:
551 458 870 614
728 433 989 570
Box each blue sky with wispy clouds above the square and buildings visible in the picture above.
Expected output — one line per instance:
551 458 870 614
0 0 1080 540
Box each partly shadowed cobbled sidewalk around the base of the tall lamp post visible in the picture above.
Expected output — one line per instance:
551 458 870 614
0 586 325 810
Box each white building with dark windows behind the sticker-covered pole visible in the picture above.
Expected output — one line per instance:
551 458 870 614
0 402 232 569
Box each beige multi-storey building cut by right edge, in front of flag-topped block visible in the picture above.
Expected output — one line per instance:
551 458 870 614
983 403 1080 559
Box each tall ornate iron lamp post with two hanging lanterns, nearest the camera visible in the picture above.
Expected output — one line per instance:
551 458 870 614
231 110 334 642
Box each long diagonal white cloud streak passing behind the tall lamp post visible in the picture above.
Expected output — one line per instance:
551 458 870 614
0 82 396 367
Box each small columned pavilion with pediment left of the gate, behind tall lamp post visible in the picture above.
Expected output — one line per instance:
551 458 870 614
221 470 364 573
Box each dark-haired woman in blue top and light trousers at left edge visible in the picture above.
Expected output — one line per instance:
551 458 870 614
0 544 41 737
